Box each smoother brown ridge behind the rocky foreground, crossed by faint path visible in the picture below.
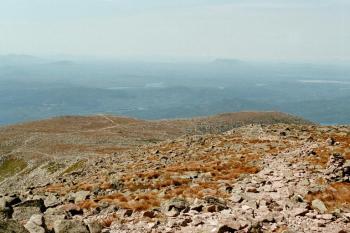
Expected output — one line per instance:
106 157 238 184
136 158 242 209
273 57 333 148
0 112 311 189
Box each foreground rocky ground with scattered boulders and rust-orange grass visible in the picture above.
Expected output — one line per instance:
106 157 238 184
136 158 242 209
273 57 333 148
0 119 350 233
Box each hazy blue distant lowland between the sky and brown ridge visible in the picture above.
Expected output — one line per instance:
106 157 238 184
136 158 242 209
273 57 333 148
0 55 350 125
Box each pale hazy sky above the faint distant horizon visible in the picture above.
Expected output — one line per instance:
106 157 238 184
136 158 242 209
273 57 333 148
0 0 350 60
